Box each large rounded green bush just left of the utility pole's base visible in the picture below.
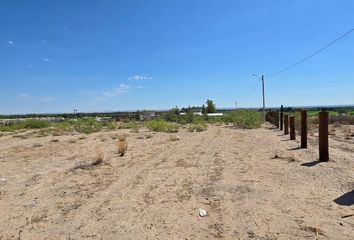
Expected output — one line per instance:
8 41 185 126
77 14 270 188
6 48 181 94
222 110 263 129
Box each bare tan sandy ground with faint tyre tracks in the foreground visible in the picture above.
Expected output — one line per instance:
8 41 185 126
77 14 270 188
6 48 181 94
0 126 354 239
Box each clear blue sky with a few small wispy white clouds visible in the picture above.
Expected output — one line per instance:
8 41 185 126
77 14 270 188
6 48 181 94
0 0 354 114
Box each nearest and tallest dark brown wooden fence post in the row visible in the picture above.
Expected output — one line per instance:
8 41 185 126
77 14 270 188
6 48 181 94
318 110 329 162
